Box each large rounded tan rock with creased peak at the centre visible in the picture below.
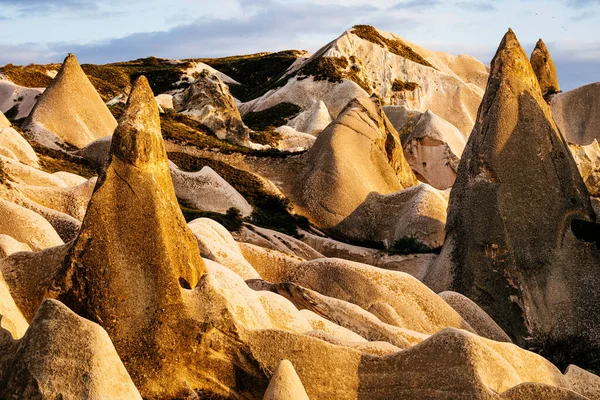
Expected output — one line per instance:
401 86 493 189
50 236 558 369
294 97 417 228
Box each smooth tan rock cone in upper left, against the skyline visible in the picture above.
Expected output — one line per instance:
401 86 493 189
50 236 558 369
25 54 117 148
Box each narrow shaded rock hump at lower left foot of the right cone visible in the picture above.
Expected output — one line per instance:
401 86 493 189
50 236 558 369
439 291 512 342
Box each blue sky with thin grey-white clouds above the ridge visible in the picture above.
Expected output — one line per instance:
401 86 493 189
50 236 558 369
0 0 600 89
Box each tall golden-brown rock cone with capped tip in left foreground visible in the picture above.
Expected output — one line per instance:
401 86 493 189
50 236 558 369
58 77 205 390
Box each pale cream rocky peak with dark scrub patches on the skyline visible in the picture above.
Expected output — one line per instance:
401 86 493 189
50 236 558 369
240 25 487 135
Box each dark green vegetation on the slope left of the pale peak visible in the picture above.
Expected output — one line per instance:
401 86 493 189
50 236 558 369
200 50 303 101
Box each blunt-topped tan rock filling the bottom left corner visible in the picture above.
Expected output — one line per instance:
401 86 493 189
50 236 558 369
0 300 141 400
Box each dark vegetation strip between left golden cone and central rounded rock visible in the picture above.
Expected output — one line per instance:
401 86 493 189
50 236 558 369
169 152 308 235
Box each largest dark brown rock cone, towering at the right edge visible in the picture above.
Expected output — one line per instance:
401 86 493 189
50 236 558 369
425 31 600 368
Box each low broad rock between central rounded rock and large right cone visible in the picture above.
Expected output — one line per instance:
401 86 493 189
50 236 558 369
332 183 449 253
